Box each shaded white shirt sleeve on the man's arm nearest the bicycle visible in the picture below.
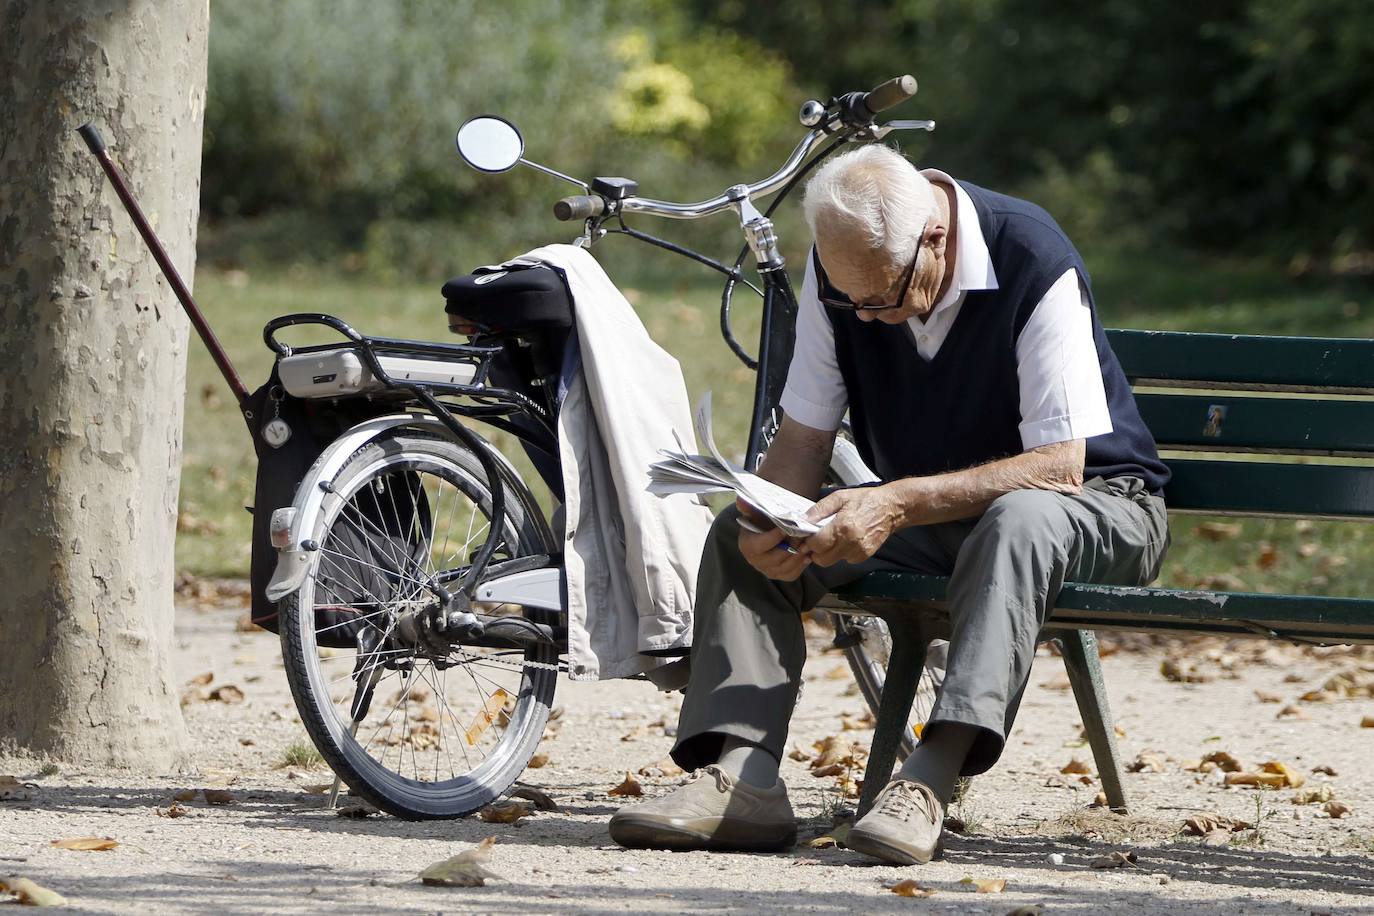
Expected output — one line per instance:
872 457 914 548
779 253 849 433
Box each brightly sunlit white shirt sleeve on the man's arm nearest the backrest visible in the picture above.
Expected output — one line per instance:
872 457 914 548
1016 268 1112 450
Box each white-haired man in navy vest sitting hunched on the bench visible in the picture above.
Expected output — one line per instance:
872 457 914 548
610 146 1168 864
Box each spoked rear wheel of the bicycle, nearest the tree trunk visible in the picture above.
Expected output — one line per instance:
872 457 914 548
280 431 558 818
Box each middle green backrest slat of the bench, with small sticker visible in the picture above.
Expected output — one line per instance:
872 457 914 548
1135 393 1374 455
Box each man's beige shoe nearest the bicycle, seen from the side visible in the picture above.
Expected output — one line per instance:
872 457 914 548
610 765 797 850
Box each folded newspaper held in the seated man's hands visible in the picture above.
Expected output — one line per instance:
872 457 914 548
649 391 830 537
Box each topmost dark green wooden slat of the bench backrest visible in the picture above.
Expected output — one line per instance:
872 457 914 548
1107 330 1374 389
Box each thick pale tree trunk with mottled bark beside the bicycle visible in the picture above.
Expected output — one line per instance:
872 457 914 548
0 0 209 772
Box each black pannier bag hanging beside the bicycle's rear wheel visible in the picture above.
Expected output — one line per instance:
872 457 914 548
243 367 430 648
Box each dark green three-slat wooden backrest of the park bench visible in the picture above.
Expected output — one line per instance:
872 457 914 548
1107 331 1374 518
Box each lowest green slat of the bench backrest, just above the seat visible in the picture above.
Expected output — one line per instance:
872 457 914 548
1164 459 1374 519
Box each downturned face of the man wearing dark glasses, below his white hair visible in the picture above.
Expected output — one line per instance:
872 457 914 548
816 221 945 324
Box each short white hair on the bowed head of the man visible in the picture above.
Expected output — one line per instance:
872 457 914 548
802 144 940 264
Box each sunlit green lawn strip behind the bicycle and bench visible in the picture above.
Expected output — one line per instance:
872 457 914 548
177 239 1374 595
